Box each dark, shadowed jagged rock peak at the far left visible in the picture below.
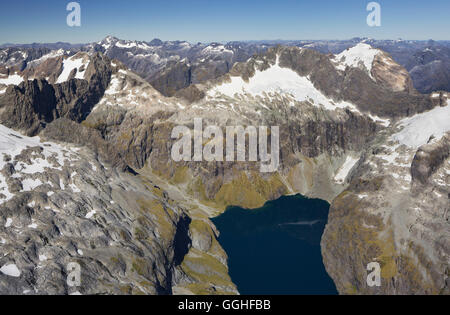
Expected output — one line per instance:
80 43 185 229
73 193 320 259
0 54 111 135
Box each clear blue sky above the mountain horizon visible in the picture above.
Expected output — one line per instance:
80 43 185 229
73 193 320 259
0 0 450 44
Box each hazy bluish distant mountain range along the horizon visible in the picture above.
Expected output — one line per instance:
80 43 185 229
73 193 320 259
0 36 450 96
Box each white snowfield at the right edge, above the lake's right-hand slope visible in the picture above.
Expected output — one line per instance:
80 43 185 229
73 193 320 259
392 101 450 149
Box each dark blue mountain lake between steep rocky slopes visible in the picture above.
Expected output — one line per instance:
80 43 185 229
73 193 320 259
213 195 337 295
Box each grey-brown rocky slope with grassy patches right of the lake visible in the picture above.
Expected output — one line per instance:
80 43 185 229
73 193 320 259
322 127 450 294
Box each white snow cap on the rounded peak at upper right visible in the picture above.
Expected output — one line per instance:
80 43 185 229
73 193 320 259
333 43 381 76
